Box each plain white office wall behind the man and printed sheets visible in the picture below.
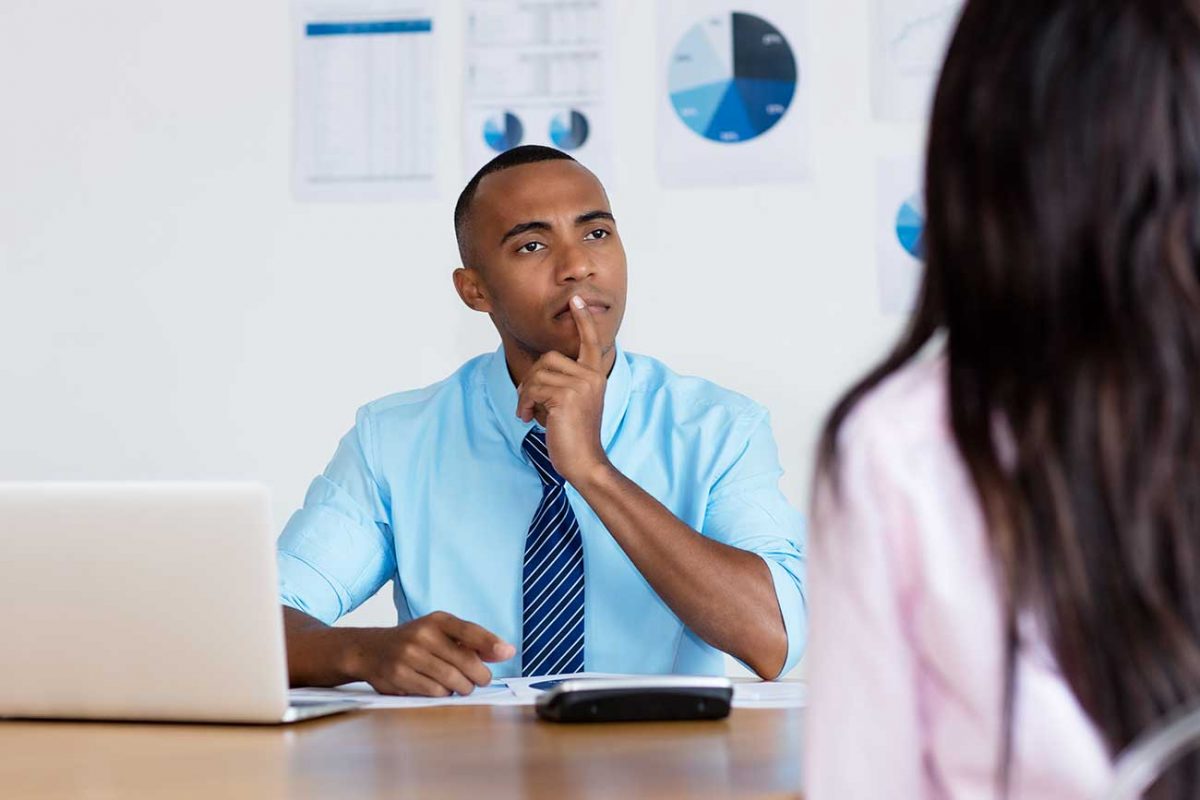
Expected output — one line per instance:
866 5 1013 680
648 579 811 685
0 0 920 638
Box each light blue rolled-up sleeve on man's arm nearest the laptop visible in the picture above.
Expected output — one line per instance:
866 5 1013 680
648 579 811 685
277 409 396 625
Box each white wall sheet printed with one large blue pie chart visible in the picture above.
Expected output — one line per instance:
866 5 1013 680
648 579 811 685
656 0 810 187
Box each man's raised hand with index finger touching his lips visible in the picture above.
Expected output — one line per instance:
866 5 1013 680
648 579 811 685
517 296 608 483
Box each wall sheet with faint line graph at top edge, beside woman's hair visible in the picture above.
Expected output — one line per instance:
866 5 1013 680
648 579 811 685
871 0 962 121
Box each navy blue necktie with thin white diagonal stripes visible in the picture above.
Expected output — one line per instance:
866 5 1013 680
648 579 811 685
521 429 583 675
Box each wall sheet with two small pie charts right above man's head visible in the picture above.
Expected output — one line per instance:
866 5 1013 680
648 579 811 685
463 0 613 176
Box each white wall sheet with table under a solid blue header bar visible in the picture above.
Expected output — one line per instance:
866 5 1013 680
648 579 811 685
292 0 437 200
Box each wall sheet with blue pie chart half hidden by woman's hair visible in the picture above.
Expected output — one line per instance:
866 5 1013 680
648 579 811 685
875 157 925 314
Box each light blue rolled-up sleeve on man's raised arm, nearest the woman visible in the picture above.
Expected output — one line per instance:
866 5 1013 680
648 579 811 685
701 409 808 674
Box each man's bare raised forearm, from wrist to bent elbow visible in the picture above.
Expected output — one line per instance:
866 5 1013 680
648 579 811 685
574 464 787 679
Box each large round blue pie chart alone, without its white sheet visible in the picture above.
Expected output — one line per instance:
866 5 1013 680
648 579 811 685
667 12 798 144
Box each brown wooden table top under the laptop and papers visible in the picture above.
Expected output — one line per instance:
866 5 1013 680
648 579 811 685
0 706 803 800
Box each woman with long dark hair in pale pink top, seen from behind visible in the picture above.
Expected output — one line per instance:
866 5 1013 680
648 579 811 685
805 0 1200 800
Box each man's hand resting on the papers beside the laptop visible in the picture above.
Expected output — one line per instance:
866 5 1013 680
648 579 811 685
349 612 516 697
